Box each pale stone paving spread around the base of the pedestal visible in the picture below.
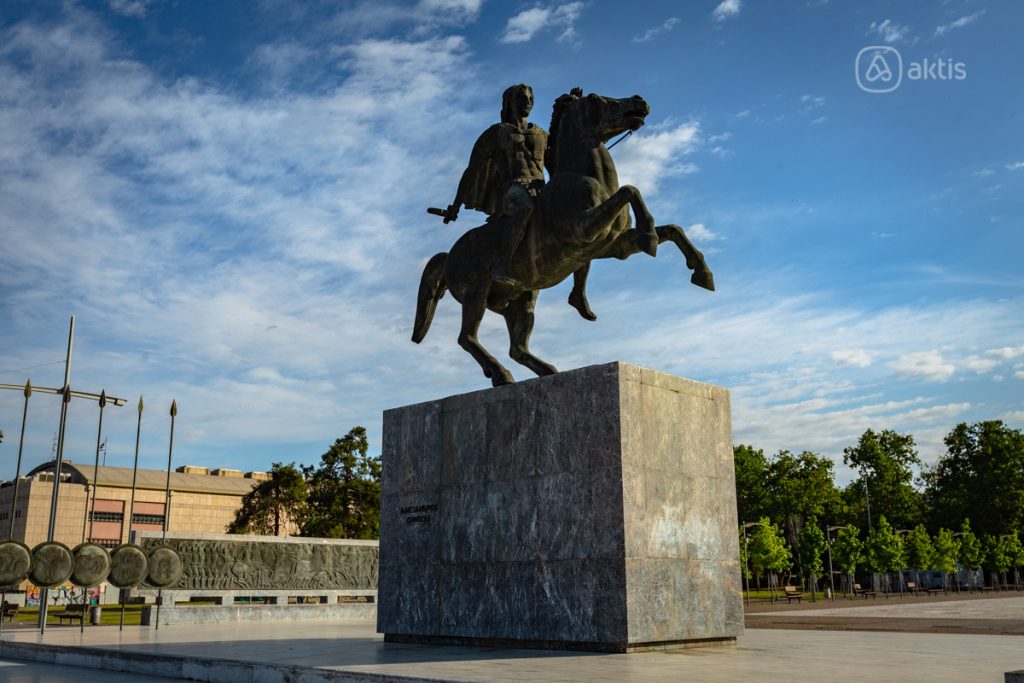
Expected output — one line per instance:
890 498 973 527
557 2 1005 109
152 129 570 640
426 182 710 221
0 623 1024 683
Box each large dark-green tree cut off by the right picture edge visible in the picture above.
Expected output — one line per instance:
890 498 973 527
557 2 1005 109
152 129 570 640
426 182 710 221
923 420 1024 536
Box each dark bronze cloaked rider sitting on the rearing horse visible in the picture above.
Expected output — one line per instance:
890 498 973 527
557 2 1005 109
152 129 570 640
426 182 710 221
444 83 597 321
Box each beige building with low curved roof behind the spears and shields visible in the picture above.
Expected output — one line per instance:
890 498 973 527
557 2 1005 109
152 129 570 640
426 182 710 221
0 461 269 548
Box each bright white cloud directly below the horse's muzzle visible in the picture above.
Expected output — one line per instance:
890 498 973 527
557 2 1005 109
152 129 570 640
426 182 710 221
612 122 700 196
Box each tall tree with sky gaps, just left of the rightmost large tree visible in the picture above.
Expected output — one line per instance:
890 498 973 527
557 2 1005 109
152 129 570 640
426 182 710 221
843 429 925 528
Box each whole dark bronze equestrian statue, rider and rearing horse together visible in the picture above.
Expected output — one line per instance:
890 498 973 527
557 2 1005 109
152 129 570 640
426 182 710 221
413 85 715 386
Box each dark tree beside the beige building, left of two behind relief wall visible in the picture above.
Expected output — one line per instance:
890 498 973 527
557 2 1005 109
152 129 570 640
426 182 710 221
227 463 307 536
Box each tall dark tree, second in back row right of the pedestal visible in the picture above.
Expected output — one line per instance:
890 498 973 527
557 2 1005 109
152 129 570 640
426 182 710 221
768 451 839 573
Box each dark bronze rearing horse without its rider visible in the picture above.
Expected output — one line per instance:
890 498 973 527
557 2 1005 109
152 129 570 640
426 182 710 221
413 92 715 386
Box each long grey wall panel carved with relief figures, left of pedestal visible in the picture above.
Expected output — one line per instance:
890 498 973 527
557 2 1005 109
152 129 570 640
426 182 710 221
139 537 379 591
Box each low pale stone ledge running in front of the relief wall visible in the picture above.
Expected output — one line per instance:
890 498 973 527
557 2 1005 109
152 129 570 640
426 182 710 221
142 602 377 626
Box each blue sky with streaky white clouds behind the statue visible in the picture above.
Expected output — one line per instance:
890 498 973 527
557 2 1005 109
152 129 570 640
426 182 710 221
0 0 1024 480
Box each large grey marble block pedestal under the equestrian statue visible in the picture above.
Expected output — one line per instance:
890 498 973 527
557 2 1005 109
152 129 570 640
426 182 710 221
377 362 743 652
